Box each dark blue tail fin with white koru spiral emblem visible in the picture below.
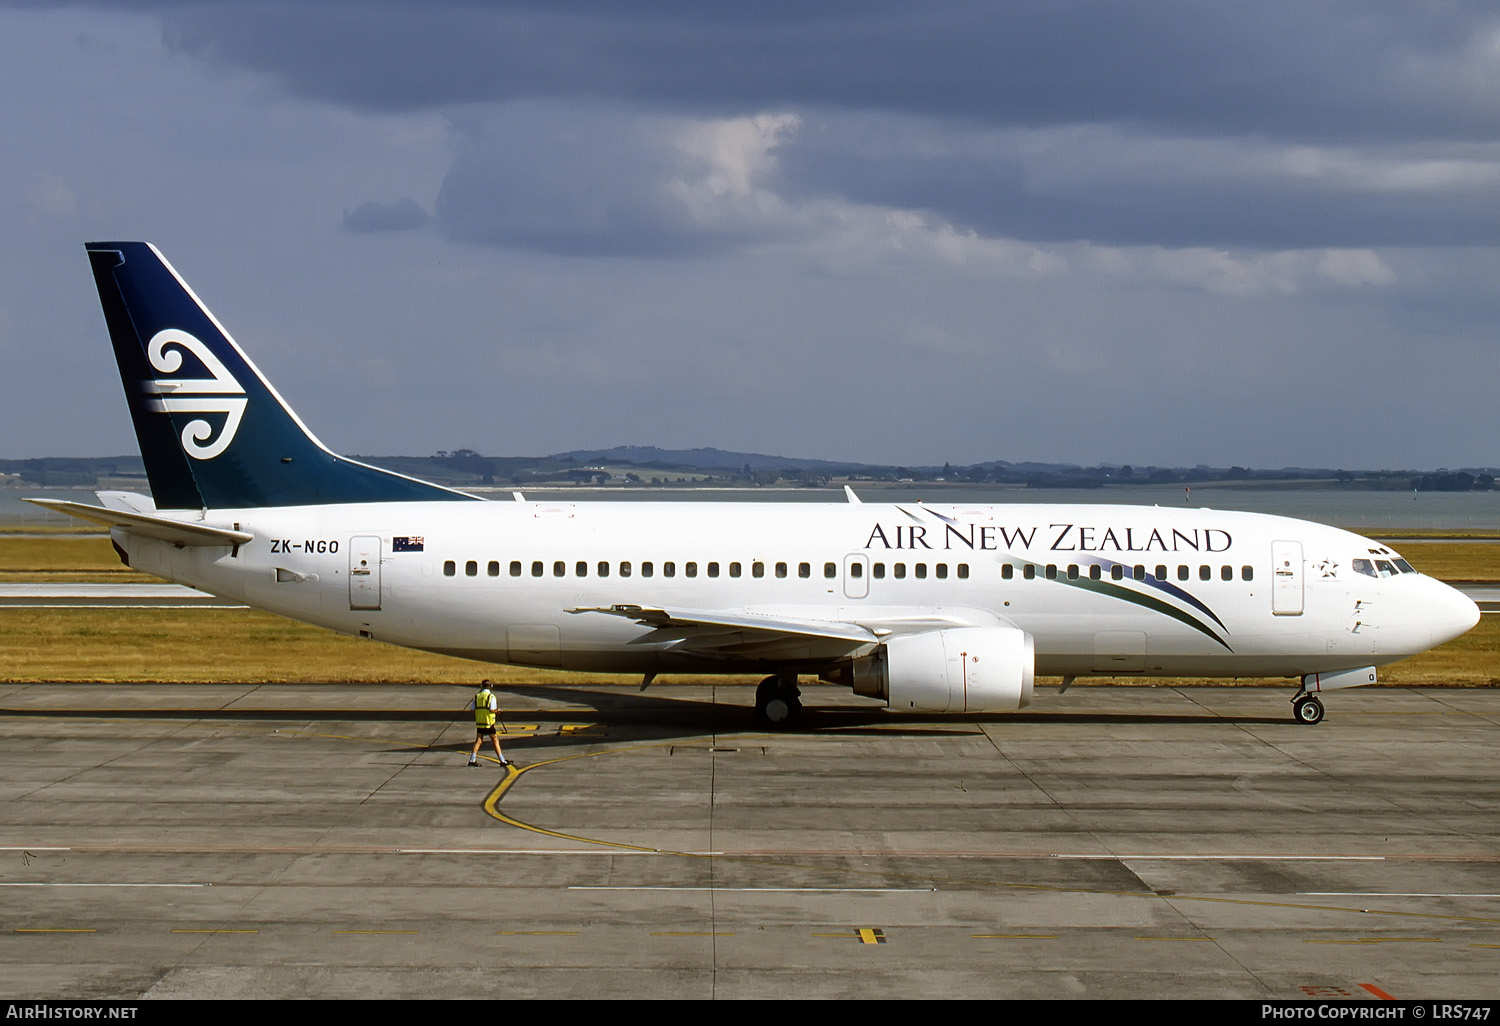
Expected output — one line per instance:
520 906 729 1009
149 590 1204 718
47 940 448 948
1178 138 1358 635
87 242 476 510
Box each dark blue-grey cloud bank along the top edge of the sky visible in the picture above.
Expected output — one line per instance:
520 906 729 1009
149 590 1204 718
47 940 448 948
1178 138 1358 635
143 0 1500 141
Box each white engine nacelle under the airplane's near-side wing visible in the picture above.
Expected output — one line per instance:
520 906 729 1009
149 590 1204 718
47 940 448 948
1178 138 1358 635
851 627 1037 713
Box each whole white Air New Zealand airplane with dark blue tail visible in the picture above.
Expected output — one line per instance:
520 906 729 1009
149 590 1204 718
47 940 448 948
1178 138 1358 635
32 242 1479 728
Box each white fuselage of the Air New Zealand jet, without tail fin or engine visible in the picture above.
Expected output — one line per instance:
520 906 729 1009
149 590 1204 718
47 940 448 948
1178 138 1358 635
114 501 1478 677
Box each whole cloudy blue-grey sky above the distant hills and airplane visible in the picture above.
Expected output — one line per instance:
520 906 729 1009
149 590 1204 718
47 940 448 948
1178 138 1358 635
0 0 1500 470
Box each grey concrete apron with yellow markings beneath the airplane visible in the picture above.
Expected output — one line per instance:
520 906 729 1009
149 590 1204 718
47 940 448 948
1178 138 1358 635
0 684 1500 1001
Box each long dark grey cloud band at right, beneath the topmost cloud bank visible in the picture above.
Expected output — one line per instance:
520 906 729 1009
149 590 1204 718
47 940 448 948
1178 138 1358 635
779 117 1500 249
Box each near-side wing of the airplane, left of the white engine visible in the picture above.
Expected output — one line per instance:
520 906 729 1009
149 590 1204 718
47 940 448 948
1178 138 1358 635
567 605 888 659
